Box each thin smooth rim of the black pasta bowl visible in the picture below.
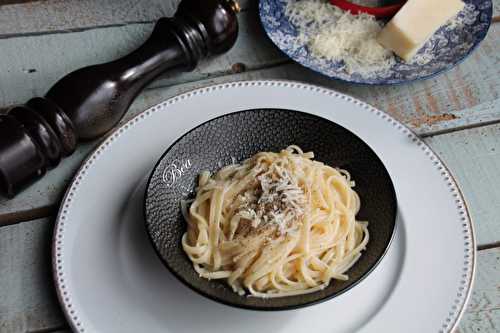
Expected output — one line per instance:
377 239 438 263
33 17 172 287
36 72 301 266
142 108 398 312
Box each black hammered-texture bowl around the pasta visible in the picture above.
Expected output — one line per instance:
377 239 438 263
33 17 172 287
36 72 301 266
144 109 397 310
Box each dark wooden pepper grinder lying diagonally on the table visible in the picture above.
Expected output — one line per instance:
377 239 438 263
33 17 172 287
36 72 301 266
0 0 239 197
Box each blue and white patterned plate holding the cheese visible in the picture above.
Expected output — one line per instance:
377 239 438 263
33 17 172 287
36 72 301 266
259 0 492 85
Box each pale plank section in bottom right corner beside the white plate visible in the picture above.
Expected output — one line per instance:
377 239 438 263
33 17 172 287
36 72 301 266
455 248 500 333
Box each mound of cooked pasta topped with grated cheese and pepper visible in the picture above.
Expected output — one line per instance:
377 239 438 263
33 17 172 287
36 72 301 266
182 146 369 297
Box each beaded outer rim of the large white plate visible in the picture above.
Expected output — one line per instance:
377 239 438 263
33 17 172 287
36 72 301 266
52 80 477 333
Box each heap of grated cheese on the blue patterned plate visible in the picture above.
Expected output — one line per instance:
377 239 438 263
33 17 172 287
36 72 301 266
285 0 395 75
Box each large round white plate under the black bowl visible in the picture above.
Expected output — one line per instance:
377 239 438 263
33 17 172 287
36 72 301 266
53 81 475 333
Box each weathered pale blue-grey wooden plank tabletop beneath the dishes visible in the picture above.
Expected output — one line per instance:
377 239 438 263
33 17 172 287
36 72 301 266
0 0 500 333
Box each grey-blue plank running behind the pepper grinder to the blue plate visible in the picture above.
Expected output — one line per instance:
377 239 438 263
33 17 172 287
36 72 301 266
0 8 285 107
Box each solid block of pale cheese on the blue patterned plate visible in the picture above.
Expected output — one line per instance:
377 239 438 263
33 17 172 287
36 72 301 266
377 0 464 61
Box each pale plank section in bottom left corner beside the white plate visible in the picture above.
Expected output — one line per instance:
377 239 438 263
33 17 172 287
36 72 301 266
0 219 65 333
